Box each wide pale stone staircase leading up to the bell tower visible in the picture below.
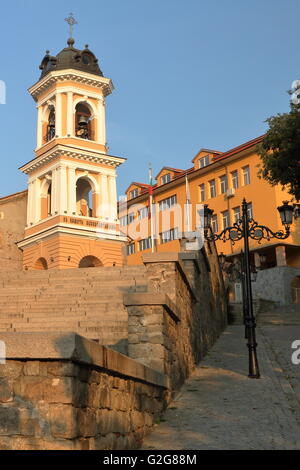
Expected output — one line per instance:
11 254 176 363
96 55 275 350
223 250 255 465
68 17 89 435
0 266 147 354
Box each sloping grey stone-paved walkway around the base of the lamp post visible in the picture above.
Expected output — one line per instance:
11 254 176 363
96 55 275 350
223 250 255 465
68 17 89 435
143 326 300 450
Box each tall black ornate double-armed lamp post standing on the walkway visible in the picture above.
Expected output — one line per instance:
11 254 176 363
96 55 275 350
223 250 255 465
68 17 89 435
204 198 294 379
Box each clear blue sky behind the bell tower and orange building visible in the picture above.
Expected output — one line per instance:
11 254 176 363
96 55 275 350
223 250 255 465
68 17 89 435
0 0 300 196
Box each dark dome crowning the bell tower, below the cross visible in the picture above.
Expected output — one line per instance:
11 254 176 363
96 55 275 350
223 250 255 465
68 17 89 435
40 38 103 79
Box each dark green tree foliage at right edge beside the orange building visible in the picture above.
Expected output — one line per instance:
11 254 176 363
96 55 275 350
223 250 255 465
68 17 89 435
257 92 300 201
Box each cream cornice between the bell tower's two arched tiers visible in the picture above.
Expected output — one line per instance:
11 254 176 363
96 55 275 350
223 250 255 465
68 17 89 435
19 144 126 174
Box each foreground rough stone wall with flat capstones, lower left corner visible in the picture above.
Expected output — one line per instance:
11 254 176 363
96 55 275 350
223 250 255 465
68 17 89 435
0 333 168 450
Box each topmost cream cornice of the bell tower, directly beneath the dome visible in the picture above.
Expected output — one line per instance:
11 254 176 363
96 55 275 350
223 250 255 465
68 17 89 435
28 69 114 101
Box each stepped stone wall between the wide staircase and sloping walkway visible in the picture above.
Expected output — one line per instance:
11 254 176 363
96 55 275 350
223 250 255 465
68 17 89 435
124 241 227 392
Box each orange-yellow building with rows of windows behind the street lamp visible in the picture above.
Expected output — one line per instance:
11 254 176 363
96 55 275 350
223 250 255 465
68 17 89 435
119 137 300 268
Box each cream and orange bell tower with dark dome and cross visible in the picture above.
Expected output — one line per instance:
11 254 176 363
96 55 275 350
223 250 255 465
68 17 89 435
18 16 126 269
